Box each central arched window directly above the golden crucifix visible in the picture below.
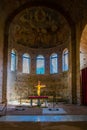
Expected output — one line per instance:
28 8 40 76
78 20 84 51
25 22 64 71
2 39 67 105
36 55 45 74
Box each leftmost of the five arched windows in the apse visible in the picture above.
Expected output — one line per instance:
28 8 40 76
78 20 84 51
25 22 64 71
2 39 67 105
11 49 17 71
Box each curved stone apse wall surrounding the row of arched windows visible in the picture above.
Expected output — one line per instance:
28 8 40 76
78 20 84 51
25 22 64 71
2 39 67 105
7 43 70 102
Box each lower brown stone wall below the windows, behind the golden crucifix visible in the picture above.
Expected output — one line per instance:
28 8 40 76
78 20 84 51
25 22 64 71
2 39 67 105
7 72 69 101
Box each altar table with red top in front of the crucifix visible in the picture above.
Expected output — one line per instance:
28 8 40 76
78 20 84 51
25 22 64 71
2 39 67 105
29 96 48 107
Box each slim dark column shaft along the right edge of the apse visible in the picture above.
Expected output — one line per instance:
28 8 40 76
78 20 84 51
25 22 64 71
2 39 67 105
70 27 77 104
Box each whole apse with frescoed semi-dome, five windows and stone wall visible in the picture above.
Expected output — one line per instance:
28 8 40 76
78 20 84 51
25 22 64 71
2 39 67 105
7 6 71 102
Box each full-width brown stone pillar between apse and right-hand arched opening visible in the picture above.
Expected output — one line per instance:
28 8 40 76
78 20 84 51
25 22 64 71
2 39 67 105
69 27 80 104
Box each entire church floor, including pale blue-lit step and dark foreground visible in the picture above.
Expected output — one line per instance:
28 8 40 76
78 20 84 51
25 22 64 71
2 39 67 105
0 103 87 130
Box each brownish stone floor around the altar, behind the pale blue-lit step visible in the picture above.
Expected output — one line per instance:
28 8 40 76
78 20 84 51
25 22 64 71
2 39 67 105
6 103 87 115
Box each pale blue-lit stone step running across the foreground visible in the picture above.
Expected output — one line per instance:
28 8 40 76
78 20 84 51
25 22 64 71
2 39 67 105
0 115 87 122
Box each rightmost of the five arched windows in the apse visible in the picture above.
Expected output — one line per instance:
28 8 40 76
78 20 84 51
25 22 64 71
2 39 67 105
62 48 69 71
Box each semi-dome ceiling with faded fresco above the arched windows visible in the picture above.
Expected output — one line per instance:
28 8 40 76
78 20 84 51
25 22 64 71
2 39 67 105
9 7 70 48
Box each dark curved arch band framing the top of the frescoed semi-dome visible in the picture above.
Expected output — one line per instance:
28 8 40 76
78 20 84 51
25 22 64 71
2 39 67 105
6 0 74 28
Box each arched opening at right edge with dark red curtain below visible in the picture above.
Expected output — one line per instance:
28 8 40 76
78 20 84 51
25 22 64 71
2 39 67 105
79 24 87 105
